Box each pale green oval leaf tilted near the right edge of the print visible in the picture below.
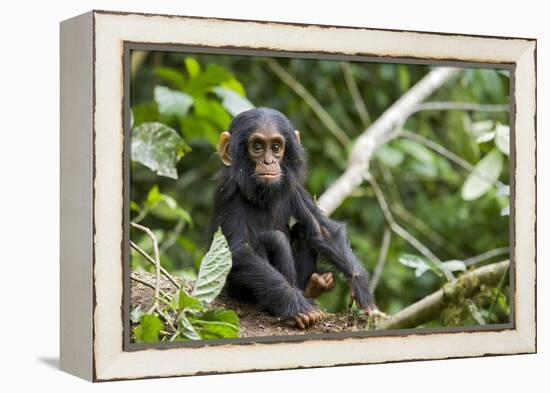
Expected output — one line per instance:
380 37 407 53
462 149 503 201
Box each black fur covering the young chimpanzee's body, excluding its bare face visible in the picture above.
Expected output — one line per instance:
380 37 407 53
211 108 375 317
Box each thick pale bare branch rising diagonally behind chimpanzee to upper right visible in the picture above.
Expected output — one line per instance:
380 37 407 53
318 67 460 215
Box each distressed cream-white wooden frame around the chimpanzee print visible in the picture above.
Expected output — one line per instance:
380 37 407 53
61 11 536 381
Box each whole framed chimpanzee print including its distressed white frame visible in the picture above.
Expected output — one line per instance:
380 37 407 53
60 11 536 381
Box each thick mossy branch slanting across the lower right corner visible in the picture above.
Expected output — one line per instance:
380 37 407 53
376 261 510 330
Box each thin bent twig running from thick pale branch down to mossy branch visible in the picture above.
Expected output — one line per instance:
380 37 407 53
365 173 455 281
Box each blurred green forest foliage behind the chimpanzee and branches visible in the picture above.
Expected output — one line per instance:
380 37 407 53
130 51 510 326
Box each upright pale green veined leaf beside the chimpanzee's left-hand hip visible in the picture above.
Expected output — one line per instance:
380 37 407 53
191 229 232 303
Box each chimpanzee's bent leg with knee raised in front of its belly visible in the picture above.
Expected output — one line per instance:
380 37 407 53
260 230 296 286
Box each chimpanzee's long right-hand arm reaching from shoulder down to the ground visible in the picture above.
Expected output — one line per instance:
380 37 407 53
293 189 376 313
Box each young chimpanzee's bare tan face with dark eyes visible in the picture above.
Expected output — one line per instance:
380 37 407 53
247 129 285 183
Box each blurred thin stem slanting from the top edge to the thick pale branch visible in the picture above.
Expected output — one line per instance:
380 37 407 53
267 59 351 147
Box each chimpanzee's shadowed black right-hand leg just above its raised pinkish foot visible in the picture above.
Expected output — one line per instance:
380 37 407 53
290 223 317 290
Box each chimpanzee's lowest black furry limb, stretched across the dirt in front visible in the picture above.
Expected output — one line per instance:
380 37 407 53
228 242 316 317
